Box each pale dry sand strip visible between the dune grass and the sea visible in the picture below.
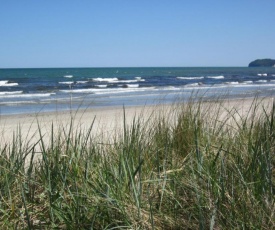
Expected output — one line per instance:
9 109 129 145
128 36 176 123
0 98 273 146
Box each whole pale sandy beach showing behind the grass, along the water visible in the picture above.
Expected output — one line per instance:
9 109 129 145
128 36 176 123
0 97 273 144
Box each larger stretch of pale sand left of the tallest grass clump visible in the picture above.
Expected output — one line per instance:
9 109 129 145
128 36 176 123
0 106 166 145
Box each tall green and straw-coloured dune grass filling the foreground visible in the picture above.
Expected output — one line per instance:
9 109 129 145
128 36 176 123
0 96 275 229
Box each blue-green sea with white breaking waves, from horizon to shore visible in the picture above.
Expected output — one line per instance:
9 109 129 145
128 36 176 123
0 67 275 115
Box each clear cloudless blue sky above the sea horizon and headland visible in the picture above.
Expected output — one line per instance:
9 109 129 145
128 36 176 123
0 0 275 68
